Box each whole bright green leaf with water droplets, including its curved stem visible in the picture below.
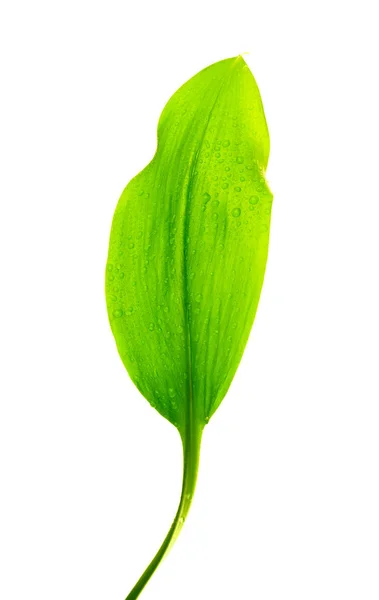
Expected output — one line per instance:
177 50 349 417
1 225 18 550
106 56 272 599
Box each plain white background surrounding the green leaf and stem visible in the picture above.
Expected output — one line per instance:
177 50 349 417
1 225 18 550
0 0 379 600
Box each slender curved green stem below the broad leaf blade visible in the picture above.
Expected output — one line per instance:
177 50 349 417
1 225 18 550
126 427 202 600
